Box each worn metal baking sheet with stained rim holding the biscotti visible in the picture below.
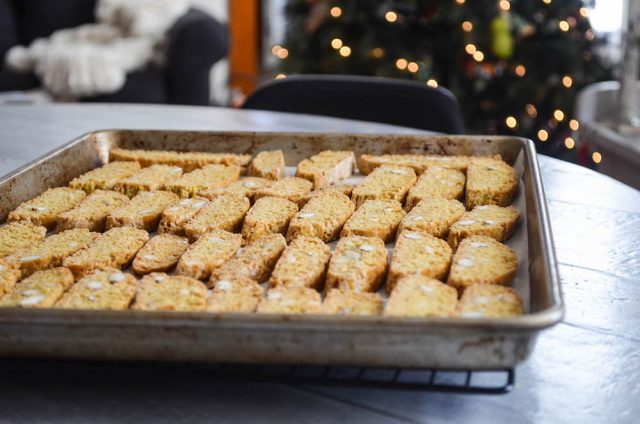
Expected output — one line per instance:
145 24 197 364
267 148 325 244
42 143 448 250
0 130 563 369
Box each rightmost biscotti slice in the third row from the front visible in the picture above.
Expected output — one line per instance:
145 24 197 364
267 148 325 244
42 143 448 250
448 205 520 249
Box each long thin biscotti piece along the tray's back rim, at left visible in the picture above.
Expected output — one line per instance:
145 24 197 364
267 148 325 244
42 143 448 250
109 148 251 172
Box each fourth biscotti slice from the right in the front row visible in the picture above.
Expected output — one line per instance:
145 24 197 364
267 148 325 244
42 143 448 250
257 286 322 314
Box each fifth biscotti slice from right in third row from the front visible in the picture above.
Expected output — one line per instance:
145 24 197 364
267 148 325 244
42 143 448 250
242 197 298 243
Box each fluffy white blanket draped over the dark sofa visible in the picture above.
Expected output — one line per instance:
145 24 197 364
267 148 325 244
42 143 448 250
5 0 189 100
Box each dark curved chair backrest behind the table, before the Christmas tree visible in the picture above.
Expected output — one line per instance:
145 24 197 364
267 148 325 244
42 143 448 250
242 75 464 134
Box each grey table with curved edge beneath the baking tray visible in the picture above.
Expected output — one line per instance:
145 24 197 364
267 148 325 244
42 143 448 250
0 105 640 423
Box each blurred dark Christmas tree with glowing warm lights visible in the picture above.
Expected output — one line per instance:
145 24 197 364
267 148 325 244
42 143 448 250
272 0 611 164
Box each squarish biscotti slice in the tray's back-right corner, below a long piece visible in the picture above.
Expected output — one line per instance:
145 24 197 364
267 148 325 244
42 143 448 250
465 158 518 209
